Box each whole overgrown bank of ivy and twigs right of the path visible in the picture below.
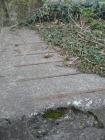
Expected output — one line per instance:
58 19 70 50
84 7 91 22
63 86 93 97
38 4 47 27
27 0 105 76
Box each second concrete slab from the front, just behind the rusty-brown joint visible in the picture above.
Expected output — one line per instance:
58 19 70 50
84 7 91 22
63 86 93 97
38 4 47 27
15 74 105 97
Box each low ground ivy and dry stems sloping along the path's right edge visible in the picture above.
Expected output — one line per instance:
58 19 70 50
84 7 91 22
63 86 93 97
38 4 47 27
40 24 105 76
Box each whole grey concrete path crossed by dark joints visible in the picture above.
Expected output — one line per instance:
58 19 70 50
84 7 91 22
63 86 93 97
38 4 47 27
0 29 105 118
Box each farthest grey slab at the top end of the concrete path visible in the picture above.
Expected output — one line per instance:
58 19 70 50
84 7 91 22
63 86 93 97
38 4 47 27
0 28 42 46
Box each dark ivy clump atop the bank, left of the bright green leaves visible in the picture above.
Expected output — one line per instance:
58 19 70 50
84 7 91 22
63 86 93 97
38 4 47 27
27 1 80 24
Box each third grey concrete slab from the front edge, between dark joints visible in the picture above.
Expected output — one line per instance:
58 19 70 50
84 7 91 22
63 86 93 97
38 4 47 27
12 62 80 81
